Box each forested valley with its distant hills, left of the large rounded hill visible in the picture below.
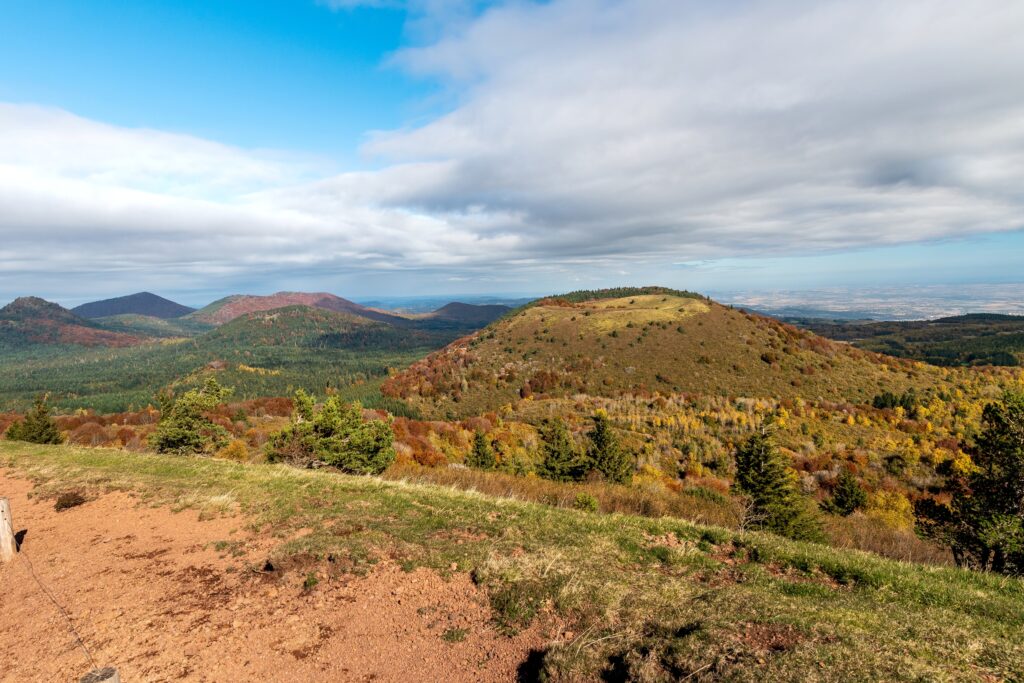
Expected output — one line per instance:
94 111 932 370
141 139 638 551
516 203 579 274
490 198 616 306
0 294 505 412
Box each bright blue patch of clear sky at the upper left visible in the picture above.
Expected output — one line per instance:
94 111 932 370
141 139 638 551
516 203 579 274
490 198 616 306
0 0 423 163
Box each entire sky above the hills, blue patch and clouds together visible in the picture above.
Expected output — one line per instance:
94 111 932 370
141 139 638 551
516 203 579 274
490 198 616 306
0 0 1024 304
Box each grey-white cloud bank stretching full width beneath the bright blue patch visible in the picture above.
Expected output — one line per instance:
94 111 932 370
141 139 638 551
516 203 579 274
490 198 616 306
0 0 1024 299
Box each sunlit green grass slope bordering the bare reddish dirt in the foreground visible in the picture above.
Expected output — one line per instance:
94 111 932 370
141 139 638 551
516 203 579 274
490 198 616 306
0 441 1024 681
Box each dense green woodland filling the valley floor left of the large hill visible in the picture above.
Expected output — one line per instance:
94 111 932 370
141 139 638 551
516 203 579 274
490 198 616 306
0 306 479 413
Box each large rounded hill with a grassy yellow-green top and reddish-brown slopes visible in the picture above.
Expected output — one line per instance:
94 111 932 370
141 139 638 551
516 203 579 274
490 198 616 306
385 290 942 417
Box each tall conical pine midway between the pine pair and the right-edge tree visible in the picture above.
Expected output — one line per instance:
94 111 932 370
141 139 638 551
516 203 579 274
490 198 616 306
735 429 821 541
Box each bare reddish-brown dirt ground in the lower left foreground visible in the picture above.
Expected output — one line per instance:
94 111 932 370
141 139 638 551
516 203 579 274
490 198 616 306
0 472 542 683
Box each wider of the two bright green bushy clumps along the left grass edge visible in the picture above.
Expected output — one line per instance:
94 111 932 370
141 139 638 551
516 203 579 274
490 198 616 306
267 390 395 474
